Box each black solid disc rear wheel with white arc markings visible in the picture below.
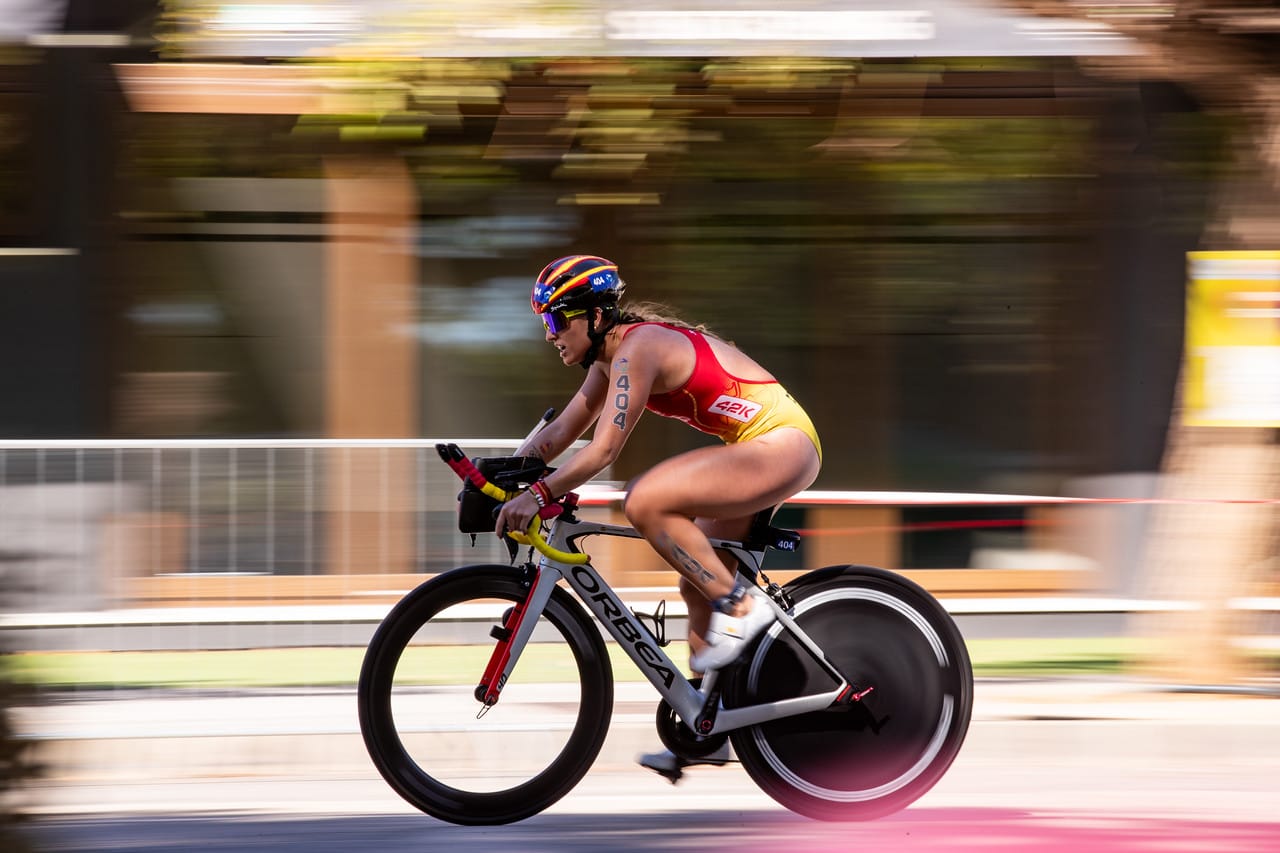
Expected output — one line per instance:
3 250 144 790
726 566 973 821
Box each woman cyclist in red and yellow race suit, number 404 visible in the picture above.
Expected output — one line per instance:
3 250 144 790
497 255 822 772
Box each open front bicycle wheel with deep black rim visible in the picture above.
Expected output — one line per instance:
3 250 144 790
357 566 613 826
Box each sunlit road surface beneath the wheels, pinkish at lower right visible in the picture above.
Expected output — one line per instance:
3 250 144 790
24 757 1280 853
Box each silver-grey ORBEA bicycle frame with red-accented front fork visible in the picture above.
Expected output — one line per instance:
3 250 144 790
488 507 865 736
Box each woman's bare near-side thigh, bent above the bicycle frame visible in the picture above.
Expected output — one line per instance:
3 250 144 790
627 429 819 520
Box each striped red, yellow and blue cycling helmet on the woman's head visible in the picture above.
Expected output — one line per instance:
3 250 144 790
529 255 626 369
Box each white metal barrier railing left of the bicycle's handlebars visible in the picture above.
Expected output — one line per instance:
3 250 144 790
0 439 586 612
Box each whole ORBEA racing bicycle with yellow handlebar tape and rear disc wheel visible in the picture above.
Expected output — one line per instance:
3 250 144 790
358 444 973 825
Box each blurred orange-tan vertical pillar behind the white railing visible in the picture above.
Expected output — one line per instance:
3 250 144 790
324 156 419 574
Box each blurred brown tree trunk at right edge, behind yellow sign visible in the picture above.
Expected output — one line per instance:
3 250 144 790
1005 0 1280 684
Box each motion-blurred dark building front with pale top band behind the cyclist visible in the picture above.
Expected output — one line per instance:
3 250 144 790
0 0 1254 612
